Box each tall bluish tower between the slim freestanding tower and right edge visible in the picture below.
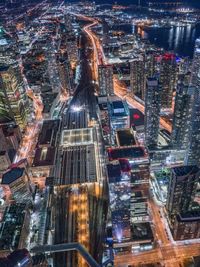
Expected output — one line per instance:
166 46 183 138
171 82 193 149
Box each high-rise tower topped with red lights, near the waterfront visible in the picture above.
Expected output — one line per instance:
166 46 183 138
160 54 176 108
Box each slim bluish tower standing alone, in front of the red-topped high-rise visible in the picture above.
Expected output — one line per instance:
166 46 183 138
145 78 161 147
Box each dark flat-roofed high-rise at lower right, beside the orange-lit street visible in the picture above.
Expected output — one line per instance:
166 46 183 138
166 166 200 224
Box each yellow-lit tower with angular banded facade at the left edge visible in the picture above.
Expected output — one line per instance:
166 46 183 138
0 64 28 129
